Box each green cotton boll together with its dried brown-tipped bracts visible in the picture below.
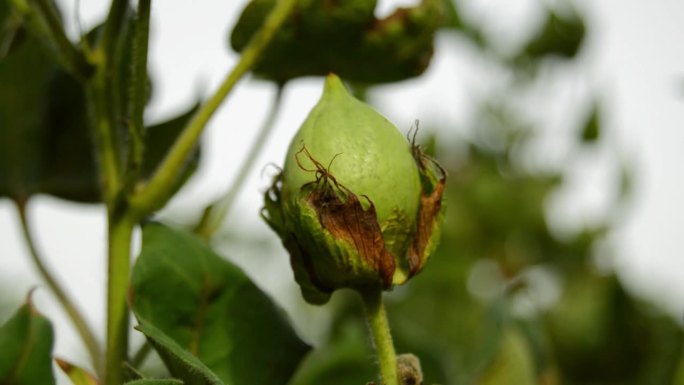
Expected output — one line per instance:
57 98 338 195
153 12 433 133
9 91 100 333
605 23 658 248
263 75 446 304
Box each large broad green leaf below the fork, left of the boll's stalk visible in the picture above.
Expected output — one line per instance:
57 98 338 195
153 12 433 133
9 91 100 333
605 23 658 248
131 223 309 385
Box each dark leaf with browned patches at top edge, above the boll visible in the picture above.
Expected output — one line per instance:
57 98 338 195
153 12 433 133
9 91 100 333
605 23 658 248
230 0 445 83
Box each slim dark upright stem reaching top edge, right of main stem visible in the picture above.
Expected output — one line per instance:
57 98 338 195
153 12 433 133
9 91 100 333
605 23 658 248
126 0 151 191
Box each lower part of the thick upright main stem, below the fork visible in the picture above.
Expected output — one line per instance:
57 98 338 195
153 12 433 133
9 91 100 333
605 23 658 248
105 211 135 385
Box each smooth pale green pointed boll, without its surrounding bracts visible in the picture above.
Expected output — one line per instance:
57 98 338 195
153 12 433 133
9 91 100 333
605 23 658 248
284 75 420 226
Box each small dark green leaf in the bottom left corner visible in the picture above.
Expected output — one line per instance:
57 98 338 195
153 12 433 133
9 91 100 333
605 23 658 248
0 299 55 385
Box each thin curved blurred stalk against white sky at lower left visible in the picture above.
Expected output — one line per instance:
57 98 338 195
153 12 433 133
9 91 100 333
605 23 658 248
17 201 102 373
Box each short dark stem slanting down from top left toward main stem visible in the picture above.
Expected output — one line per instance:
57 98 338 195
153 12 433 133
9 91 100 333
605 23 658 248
26 0 93 80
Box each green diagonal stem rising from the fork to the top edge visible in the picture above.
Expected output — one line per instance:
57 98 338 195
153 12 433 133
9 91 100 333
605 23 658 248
131 0 298 213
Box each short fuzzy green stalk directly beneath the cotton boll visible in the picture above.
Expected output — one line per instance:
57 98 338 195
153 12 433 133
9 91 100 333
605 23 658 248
359 287 399 385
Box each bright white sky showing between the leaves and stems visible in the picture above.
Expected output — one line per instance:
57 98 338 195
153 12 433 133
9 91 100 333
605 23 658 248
0 0 684 380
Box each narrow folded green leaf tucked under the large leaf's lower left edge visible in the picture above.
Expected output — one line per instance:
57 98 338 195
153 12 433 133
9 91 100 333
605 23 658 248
136 317 224 385
